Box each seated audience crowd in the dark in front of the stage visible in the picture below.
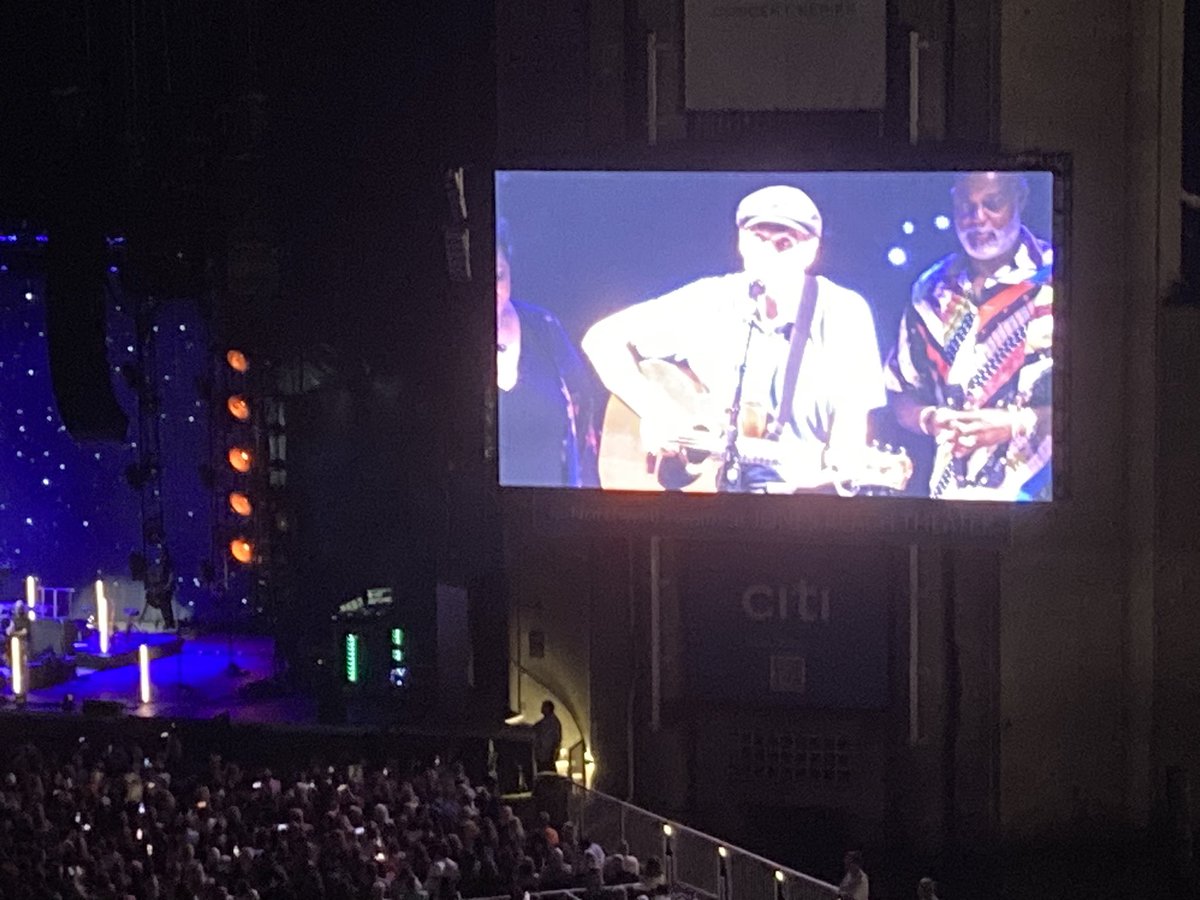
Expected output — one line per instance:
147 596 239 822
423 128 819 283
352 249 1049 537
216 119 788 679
0 732 667 900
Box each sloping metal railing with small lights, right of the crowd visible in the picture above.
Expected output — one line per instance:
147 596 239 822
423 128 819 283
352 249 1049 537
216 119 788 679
568 784 838 900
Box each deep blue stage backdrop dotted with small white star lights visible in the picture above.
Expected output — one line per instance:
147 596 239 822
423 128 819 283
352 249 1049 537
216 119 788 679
0 271 211 602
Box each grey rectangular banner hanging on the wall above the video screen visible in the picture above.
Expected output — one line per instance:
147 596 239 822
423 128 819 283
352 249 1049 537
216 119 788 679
684 0 887 112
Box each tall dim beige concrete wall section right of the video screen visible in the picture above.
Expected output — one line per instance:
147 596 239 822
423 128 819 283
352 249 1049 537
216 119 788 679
1000 0 1182 835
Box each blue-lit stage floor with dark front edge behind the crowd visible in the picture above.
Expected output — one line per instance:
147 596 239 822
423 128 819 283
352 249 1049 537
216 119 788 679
0 631 533 793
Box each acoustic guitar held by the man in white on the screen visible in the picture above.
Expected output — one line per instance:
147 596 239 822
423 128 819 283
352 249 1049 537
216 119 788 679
599 359 913 494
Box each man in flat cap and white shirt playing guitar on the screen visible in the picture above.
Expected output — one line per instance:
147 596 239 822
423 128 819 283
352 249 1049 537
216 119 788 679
582 185 906 493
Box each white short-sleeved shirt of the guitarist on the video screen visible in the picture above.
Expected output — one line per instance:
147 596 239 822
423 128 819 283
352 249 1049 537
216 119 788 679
611 272 887 465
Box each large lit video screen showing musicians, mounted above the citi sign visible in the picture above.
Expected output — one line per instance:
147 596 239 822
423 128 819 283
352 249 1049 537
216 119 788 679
496 170 1056 503
